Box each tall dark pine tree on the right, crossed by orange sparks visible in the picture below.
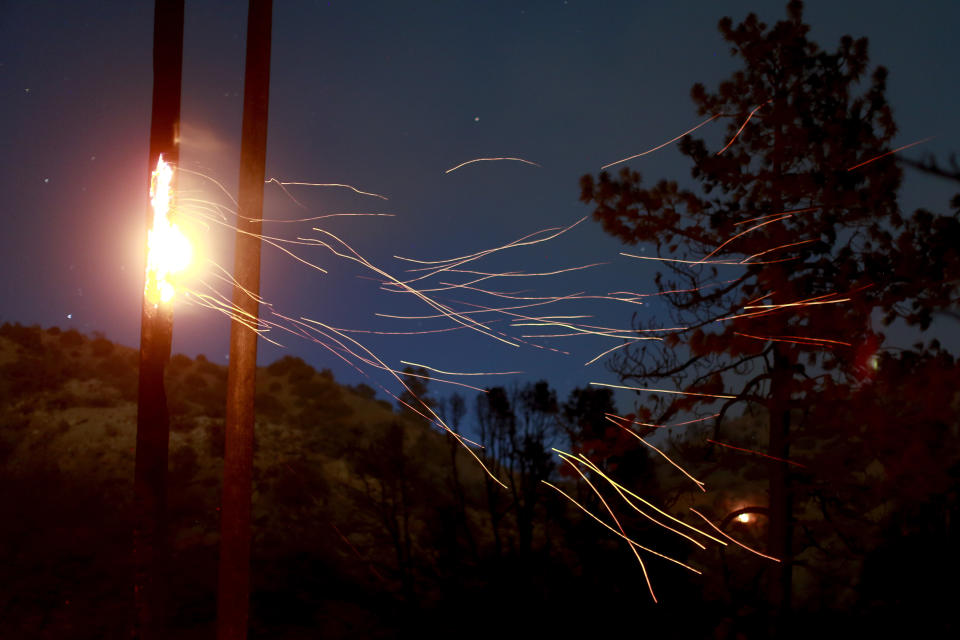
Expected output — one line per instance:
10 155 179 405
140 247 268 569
581 1 960 635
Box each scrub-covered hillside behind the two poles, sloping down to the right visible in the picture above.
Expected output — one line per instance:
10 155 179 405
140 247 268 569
0 324 696 638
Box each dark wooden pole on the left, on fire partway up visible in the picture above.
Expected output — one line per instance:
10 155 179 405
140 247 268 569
133 0 183 640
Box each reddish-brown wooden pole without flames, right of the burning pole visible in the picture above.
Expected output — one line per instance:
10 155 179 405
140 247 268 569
217 0 273 640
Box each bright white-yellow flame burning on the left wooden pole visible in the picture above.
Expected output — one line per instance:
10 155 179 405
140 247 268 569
143 155 193 306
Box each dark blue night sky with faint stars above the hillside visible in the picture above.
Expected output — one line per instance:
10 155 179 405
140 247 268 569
0 0 960 408
